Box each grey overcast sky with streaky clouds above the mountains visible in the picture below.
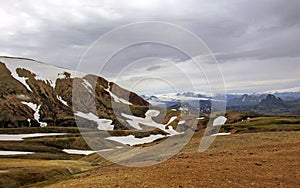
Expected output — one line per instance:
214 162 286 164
0 0 300 93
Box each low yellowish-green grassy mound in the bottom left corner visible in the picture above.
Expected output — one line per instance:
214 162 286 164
0 159 92 188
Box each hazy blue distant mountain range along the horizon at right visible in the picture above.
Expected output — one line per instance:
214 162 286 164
142 91 300 115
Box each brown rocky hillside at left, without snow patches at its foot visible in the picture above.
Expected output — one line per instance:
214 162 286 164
0 57 149 129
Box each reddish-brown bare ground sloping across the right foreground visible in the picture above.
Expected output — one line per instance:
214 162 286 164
48 131 300 188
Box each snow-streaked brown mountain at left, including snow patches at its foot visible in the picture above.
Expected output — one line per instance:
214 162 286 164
0 57 199 150
